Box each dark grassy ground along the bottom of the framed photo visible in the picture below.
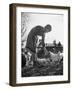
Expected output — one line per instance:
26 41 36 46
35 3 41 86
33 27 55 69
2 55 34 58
21 61 63 77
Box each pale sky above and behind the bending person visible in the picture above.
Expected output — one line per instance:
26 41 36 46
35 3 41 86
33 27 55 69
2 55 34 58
21 12 64 47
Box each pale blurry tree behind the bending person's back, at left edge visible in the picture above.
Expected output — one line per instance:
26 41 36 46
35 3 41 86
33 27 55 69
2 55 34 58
21 12 30 46
